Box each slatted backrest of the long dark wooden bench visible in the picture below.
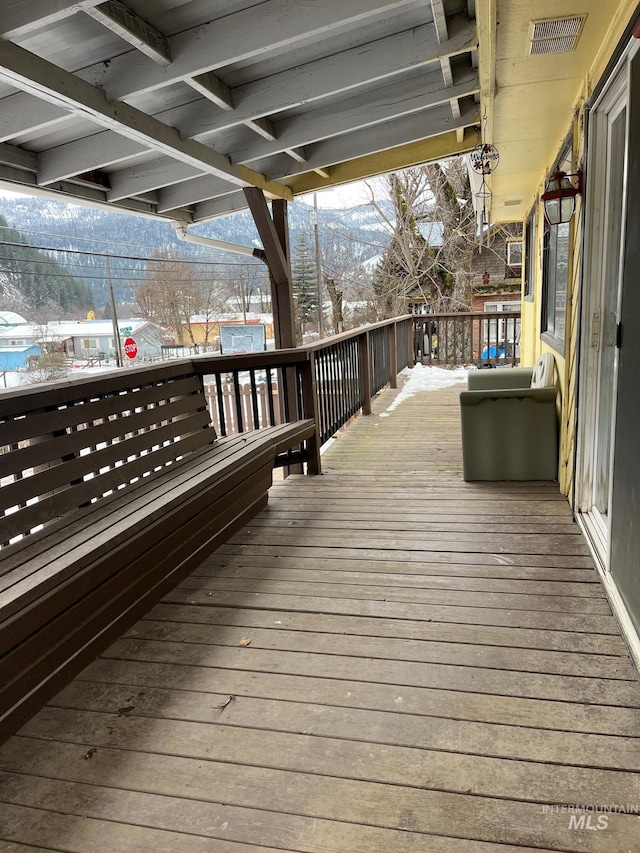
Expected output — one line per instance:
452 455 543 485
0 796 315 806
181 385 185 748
0 361 216 547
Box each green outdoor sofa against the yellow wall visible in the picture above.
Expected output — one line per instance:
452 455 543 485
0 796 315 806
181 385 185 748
460 353 558 480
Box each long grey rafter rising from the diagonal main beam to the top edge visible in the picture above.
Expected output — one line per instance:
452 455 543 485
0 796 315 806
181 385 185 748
81 0 424 99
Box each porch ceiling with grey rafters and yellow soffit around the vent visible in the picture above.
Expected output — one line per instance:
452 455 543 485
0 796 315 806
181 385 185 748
0 0 627 224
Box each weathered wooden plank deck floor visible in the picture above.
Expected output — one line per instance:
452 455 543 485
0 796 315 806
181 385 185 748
0 380 640 853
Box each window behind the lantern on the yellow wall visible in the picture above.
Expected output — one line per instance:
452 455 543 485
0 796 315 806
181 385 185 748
541 144 574 354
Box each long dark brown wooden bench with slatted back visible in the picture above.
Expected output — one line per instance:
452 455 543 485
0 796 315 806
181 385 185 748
0 361 315 740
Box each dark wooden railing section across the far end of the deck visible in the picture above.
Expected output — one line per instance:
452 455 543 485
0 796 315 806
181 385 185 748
414 311 520 366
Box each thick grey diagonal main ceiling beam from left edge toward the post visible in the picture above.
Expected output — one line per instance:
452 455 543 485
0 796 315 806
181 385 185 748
0 42 291 198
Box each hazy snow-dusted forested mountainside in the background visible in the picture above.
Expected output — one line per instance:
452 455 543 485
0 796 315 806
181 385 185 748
0 195 388 312
